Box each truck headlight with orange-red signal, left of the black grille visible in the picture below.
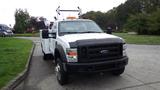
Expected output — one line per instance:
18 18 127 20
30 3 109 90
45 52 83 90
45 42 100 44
66 48 78 62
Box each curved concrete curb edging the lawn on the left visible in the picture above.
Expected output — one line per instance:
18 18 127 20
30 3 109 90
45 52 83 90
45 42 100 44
1 42 35 90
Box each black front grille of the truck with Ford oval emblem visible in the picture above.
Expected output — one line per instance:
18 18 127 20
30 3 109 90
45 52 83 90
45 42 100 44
78 43 123 62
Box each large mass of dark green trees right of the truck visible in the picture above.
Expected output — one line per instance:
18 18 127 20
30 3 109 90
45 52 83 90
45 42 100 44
82 0 160 34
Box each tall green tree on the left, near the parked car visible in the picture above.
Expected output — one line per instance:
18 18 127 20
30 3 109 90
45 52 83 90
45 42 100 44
14 9 30 33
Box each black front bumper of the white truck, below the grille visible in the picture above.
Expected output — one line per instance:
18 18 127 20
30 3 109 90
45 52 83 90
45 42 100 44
63 57 128 73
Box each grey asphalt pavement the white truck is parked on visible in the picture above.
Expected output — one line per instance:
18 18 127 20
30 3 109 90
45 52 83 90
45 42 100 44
16 37 160 90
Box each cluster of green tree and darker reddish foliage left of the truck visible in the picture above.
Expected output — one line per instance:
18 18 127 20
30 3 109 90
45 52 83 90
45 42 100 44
14 9 47 34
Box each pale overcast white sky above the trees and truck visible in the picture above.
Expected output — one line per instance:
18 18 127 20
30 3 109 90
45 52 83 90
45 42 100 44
0 0 126 26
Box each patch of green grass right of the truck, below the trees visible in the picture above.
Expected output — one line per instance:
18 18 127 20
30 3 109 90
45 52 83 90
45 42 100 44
113 33 160 45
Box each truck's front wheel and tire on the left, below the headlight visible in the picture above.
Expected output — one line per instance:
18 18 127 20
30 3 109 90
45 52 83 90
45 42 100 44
55 58 68 85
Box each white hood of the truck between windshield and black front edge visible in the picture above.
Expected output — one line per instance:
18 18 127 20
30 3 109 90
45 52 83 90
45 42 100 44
60 33 121 42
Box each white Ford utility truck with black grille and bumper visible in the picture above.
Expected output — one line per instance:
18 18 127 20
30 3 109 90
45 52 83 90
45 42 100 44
40 7 128 85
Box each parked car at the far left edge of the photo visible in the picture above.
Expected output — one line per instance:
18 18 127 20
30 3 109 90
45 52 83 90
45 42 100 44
0 24 13 37
